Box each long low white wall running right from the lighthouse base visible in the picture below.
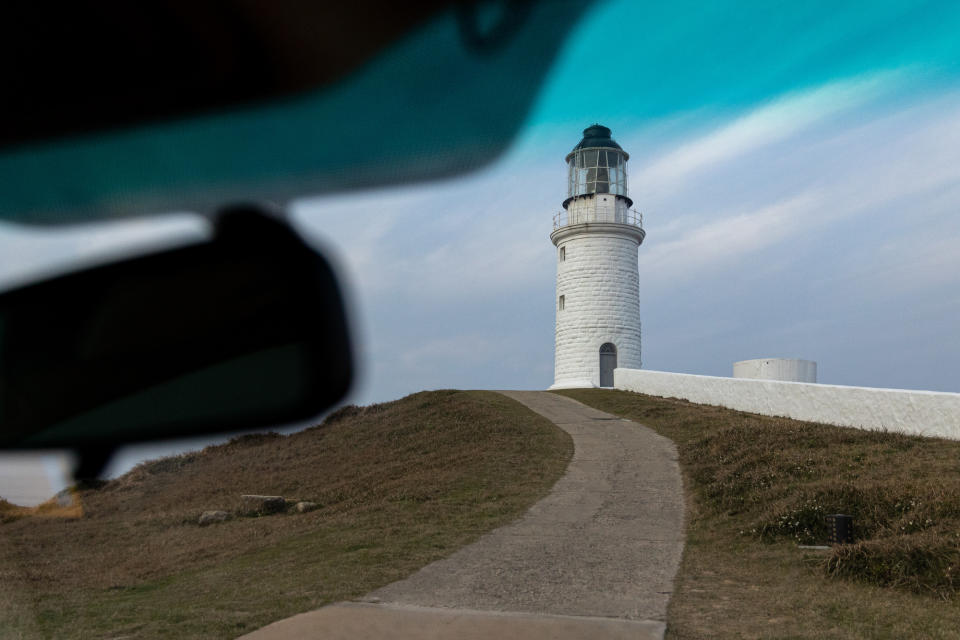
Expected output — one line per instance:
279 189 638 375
613 368 960 440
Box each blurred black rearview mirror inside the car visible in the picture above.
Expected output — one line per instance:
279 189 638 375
0 206 353 476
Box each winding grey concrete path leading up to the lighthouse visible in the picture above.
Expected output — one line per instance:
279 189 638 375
243 391 683 640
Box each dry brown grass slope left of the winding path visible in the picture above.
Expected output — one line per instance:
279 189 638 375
0 391 572 638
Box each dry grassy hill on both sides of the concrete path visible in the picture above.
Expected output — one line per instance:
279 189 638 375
0 390 960 639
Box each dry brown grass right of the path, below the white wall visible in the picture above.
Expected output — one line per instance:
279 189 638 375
562 390 960 638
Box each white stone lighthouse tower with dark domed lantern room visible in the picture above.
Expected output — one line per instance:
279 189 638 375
550 124 646 389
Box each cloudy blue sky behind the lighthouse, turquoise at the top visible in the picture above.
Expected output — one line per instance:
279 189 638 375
0 1 960 496
